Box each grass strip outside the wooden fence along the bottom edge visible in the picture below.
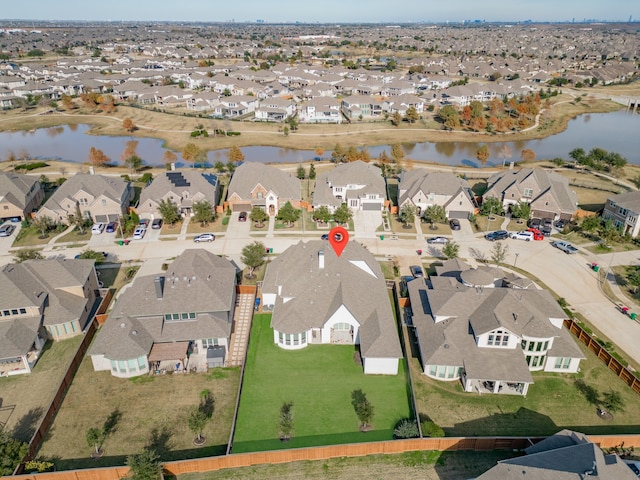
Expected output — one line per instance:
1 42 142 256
172 450 513 480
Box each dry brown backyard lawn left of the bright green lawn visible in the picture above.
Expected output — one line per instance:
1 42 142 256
39 357 240 470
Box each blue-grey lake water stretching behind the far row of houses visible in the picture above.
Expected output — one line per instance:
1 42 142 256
0 110 640 167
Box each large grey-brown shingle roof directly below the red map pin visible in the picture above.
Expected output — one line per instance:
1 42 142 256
262 240 402 358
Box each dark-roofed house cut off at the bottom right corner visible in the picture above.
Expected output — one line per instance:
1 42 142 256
476 430 638 480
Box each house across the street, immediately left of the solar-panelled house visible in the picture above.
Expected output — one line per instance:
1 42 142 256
36 173 134 223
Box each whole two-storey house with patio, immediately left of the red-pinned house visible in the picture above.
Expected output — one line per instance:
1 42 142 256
88 249 236 378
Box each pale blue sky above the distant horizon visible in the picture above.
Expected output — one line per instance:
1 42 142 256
0 0 640 25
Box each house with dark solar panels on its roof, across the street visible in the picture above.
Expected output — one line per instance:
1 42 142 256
136 169 220 218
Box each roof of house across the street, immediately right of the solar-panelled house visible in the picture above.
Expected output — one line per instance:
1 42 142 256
227 162 301 200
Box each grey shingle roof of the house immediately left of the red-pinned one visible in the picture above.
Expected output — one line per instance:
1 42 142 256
89 249 236 360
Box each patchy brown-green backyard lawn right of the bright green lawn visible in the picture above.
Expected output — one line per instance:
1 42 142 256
411 328 640 436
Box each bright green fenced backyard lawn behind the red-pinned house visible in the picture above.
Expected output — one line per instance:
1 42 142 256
233 314 410 453
